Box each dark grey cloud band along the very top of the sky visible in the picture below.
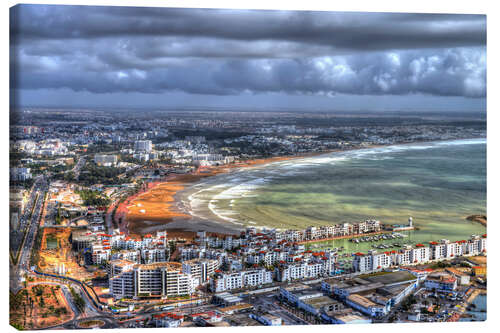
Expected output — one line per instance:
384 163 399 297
11 6 486 50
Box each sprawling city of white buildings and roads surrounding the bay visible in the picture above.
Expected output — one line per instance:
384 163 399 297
10 108 487 329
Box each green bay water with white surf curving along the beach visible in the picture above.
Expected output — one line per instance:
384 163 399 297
182 139 486 250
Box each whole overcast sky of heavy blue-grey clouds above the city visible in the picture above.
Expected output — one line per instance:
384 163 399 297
10 5 486 111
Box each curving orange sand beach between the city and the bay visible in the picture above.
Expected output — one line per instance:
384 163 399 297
117 137 485 236
